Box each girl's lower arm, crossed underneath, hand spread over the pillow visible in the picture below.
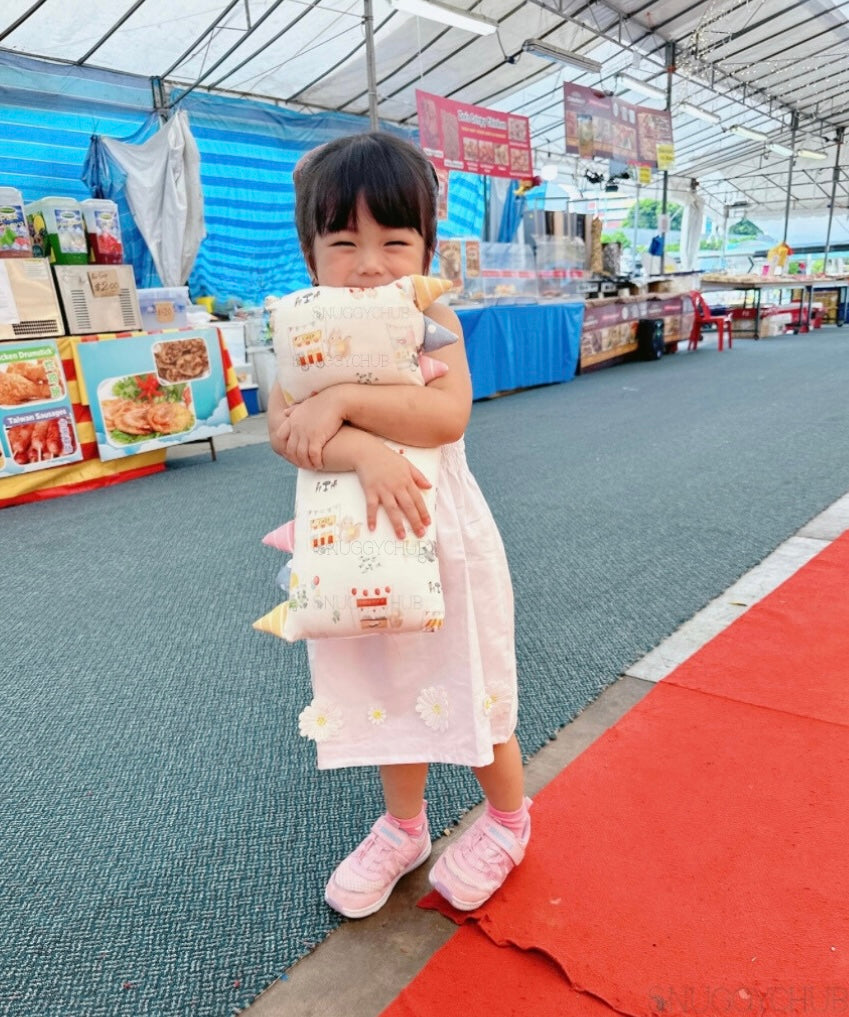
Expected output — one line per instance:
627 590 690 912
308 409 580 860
268 382 431 540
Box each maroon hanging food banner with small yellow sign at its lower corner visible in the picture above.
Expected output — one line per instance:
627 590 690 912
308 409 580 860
563 82 675 170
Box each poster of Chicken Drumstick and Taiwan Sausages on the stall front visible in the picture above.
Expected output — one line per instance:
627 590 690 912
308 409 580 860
0 340 82 477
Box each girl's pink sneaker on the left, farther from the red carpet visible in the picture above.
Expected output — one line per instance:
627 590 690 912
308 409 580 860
324 813 431 918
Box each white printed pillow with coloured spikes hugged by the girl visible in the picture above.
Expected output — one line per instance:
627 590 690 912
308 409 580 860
254 276 457 642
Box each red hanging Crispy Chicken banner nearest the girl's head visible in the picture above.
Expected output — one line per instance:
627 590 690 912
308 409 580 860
416 89 533 180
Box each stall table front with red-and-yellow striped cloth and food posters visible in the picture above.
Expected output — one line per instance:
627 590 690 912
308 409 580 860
0 328 247 507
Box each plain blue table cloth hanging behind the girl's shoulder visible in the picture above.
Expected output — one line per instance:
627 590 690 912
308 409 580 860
457 303 584 399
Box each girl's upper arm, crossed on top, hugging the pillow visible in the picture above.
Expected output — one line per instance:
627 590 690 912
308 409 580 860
272 303 472 469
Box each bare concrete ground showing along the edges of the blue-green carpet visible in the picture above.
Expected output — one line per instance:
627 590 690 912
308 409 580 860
169 414 849 1017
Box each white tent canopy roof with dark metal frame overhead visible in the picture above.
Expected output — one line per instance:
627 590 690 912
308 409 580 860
0 0 849 219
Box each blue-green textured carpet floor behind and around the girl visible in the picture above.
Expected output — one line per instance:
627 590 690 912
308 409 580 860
0 328 849 1017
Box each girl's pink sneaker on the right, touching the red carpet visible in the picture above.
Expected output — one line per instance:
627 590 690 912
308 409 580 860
428 798 531 911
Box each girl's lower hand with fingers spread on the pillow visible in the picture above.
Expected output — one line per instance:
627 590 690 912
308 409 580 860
355 441 431 540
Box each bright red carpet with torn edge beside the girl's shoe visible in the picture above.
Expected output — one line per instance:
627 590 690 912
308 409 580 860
382 533 849 1017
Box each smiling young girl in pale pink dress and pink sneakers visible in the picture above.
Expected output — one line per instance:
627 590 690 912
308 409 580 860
268 132 531 918
